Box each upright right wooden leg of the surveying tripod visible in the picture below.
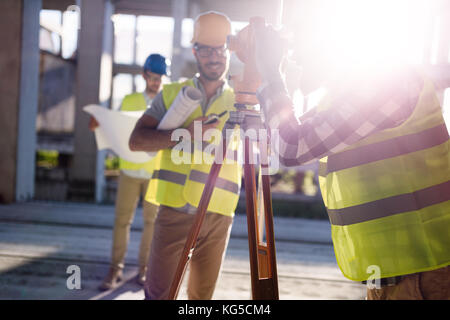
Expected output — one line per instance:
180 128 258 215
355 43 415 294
244 137 279 300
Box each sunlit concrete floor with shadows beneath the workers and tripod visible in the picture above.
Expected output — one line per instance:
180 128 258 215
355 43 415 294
0 202 365 300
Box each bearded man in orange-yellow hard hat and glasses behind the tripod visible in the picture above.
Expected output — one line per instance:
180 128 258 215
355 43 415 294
130 12 241 299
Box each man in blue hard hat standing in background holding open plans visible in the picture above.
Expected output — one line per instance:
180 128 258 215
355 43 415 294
90 54 167 290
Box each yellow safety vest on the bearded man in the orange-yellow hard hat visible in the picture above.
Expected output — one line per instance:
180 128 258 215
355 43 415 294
145 80 242 216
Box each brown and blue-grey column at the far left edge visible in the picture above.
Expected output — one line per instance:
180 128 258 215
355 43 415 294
0 0 42 203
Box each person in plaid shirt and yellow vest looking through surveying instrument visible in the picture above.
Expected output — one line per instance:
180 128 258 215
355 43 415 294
255 27 450 299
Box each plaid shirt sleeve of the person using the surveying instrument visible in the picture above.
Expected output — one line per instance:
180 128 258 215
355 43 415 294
257 71 423 166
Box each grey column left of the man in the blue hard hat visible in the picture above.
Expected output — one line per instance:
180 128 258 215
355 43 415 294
70 0 113 202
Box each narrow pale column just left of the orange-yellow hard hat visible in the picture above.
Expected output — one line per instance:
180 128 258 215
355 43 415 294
170 0 188 81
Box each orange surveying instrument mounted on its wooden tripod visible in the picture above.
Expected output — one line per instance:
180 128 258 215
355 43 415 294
168 17 279 300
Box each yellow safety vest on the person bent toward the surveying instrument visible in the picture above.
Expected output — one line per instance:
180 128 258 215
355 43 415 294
319 80 450 281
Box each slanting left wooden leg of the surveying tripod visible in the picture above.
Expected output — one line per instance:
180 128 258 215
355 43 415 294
168 142 226 300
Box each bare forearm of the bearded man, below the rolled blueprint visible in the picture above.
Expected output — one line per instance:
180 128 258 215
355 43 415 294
129 128 178 152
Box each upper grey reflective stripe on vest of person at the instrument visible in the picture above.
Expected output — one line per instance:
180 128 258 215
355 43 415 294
326 124 449 176
